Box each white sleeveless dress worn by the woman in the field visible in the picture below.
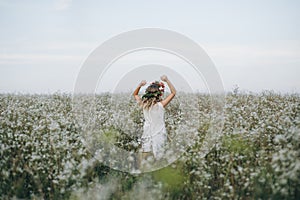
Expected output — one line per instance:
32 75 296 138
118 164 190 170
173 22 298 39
141 102 167 158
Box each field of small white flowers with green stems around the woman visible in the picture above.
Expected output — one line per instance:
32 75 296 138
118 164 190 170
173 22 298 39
0 91 300 199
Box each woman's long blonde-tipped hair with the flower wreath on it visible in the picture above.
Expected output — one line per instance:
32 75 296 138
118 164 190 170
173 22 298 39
141 81 165 110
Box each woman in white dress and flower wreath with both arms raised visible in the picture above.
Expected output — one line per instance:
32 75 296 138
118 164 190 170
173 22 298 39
133 75 176 158
